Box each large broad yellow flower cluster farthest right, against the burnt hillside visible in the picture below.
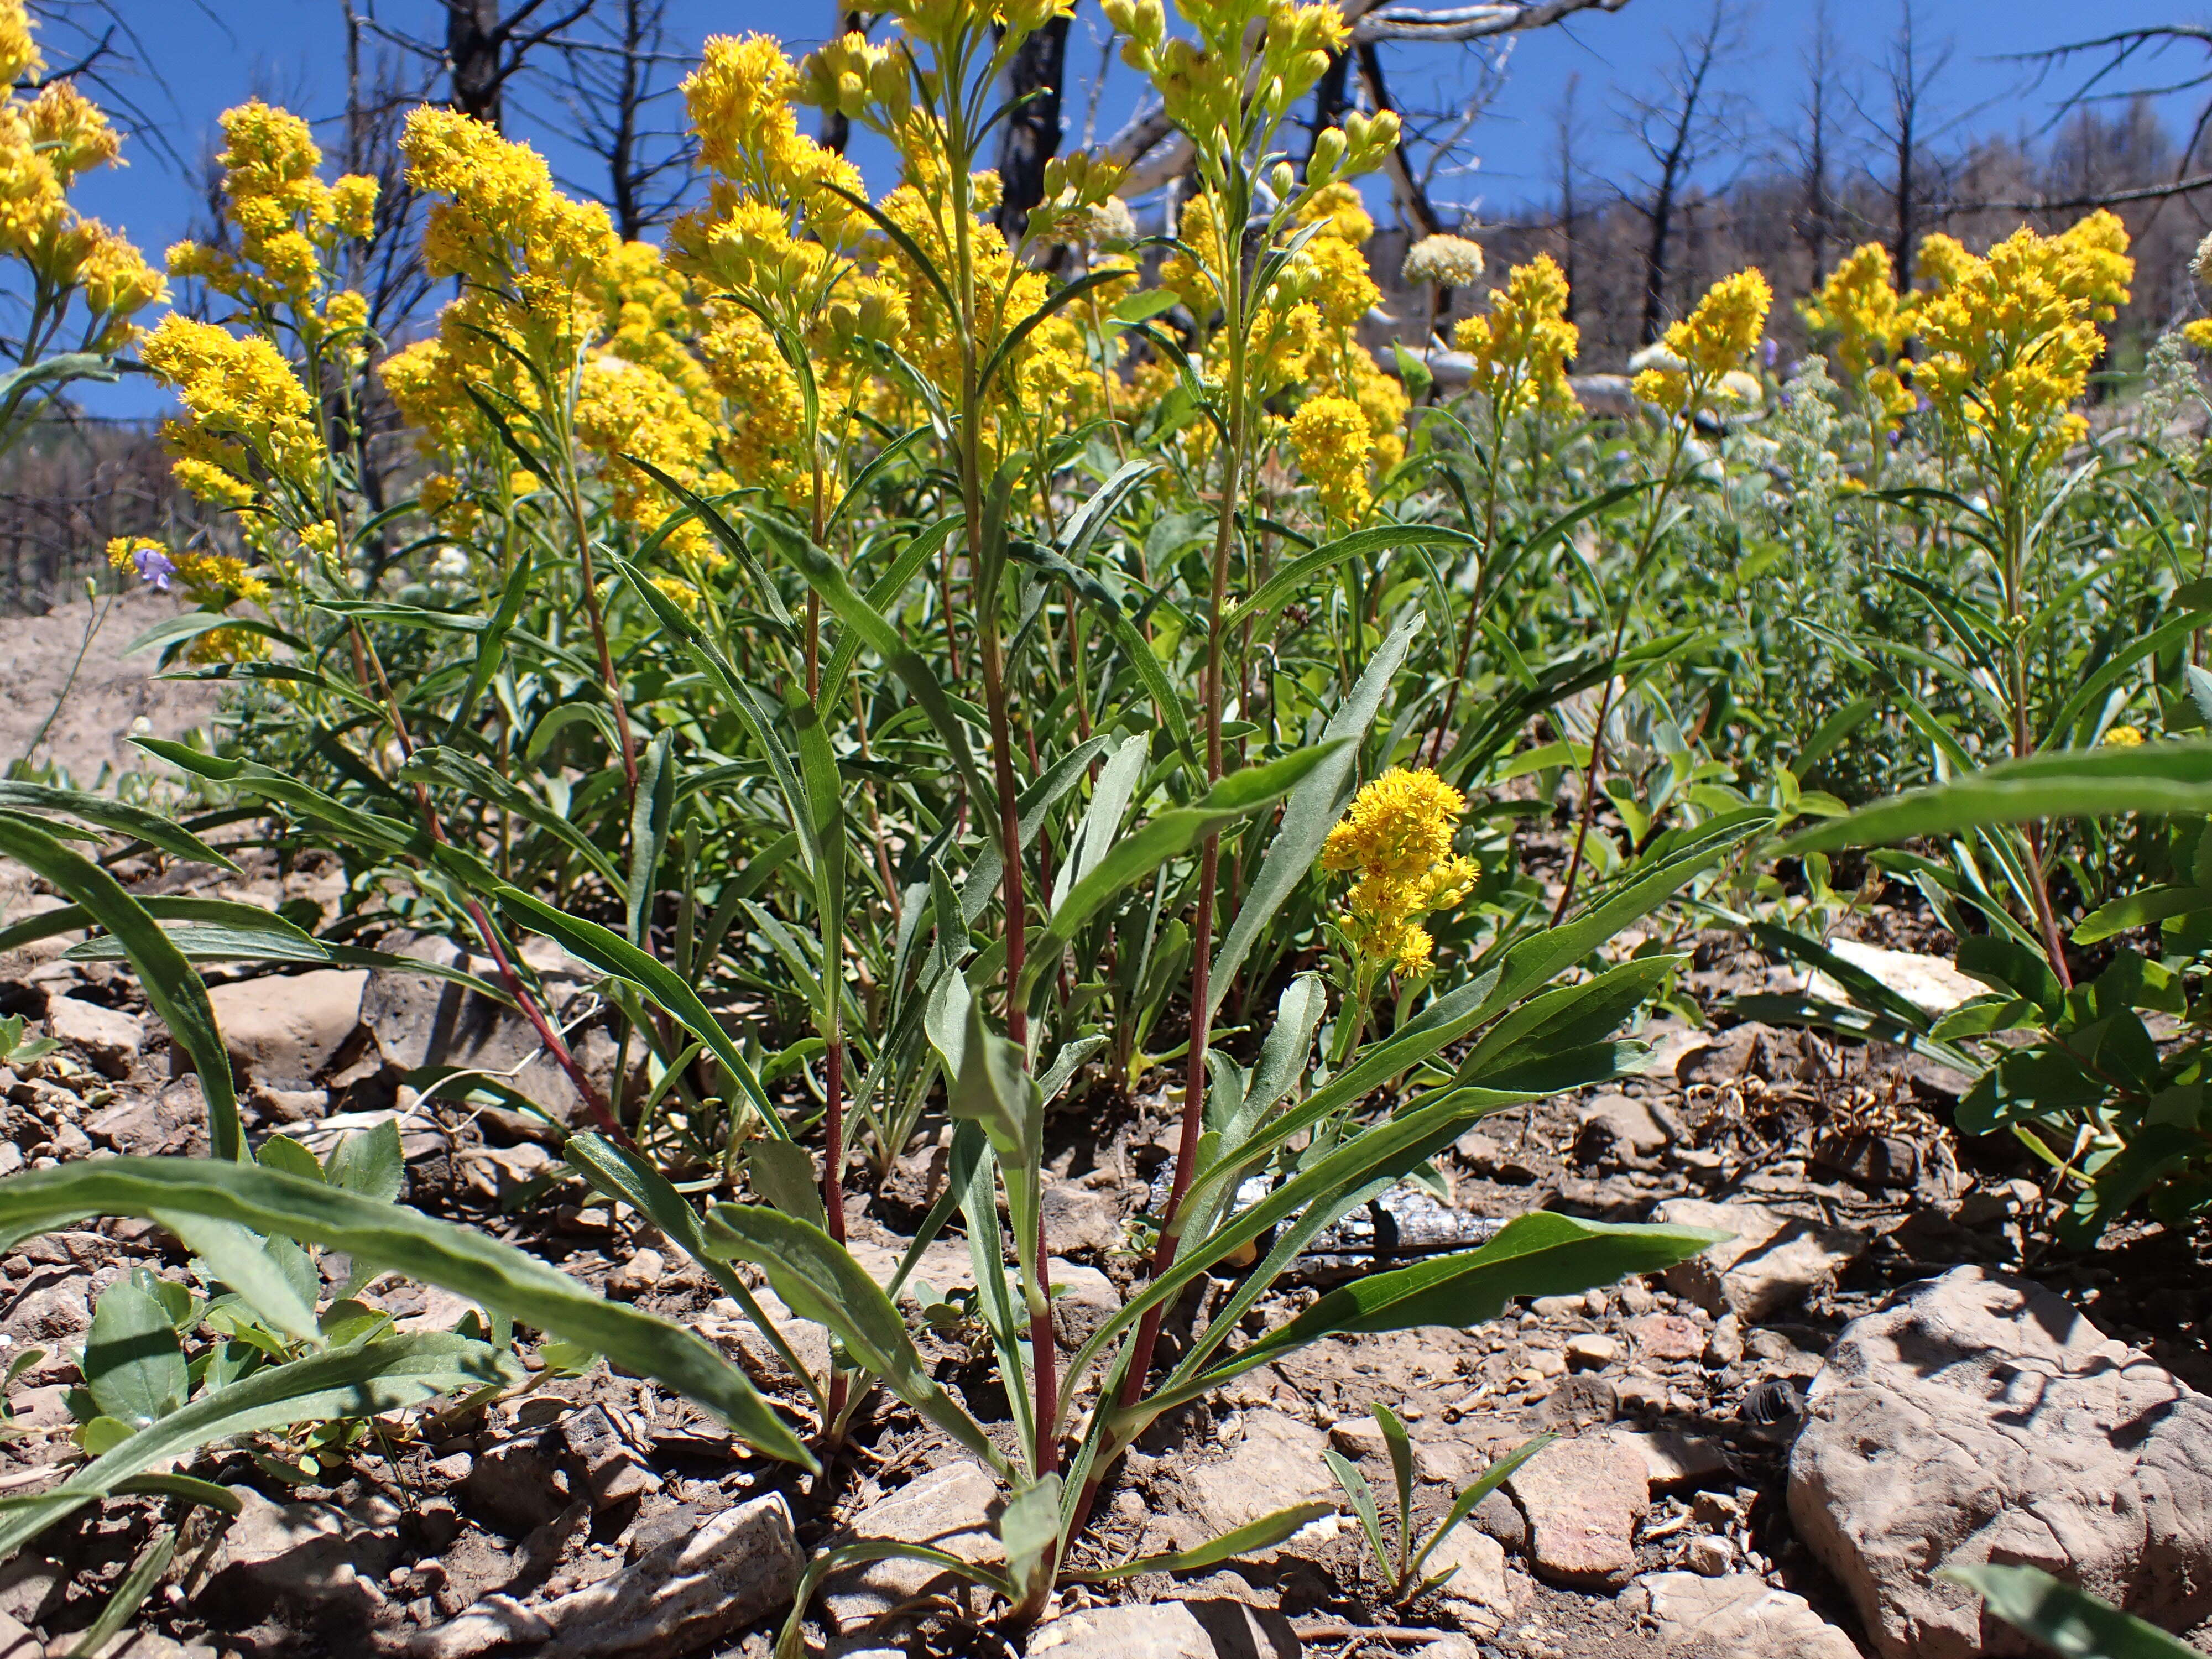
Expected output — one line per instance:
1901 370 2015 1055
1913 210 2135 467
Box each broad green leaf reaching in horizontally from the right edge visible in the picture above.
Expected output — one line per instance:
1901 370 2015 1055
1776 741 2212 856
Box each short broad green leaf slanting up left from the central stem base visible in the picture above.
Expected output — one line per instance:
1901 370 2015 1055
706 1203 1006 1475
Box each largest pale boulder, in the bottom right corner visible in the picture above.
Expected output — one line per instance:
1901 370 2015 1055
1790 1267 2212 1659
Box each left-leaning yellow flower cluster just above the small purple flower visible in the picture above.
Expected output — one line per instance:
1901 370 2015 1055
142 312 327 507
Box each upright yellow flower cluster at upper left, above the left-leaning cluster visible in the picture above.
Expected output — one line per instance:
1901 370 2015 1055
168 97 376 325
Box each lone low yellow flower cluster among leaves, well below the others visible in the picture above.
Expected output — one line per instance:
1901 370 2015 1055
1321 765 1482 973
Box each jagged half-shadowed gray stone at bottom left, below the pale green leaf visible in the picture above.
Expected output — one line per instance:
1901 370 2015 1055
195 1486 400 1624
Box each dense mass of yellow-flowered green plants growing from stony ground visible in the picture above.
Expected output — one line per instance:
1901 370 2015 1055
0 0 2212 1648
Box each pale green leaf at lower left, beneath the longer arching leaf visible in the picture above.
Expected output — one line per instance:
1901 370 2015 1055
0 1334 522 1557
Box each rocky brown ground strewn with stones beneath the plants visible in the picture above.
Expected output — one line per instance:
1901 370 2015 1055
0 852 2212 1659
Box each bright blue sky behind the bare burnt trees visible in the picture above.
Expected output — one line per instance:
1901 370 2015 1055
52 0 2212 414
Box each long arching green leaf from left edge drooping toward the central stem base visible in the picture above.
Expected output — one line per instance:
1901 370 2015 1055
0 1157 814 1469
